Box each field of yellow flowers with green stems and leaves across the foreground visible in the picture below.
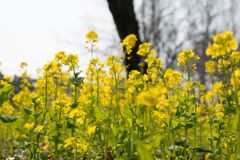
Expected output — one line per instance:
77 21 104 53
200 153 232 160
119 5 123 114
0 31 240 160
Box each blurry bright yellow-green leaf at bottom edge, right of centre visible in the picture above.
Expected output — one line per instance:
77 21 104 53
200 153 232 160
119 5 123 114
137 141 153 160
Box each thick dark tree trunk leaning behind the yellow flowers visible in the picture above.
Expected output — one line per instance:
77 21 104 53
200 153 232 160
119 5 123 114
107 0 147 75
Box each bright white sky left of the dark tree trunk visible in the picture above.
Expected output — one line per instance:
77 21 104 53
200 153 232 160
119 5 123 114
0 0 120 78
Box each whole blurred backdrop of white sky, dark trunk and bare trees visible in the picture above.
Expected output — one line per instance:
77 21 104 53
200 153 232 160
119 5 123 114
0 0 240 91
